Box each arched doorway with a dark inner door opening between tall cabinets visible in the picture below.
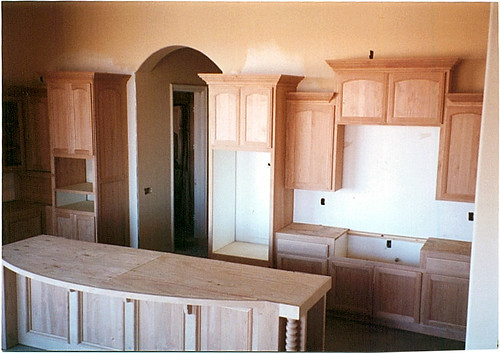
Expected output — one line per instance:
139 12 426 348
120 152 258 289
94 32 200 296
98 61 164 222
136 46 221 255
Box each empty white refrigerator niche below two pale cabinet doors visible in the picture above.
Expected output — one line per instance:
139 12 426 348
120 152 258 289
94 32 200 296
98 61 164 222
212 150 271 260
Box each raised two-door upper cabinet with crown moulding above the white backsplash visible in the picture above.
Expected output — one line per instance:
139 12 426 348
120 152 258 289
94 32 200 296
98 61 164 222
327 58 458 126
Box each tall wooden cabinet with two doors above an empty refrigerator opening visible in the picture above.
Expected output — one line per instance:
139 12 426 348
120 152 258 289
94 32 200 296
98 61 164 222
199 74 303 266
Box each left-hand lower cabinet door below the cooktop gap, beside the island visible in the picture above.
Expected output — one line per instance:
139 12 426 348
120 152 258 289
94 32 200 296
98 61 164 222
329 260 373 316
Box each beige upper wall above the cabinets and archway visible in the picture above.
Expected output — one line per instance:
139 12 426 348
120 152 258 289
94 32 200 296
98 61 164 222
2 2 489 91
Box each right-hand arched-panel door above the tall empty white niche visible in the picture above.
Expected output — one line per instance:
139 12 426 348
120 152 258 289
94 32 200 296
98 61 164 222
240 87 272 148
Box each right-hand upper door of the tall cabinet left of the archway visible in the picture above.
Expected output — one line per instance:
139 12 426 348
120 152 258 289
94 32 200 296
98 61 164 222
71 83 93 156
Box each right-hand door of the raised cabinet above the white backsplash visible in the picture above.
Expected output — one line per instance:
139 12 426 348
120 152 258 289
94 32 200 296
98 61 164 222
387 72 446 125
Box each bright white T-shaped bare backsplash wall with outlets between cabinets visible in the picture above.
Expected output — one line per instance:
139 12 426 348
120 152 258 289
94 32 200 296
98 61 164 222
294 125 474 241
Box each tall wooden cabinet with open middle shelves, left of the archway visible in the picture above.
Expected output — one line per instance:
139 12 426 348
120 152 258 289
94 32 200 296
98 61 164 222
44 72 130 245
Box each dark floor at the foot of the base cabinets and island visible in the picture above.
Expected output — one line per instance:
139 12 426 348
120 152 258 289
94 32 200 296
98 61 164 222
7 314 465 352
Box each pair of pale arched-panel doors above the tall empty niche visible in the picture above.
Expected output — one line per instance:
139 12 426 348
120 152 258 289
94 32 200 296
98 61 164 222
201 75 274 150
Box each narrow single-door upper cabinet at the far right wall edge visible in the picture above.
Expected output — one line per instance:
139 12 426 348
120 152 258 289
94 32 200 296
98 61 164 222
436 93 483 202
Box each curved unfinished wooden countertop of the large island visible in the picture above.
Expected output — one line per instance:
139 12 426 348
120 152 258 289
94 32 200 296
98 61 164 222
2 235 331 319
